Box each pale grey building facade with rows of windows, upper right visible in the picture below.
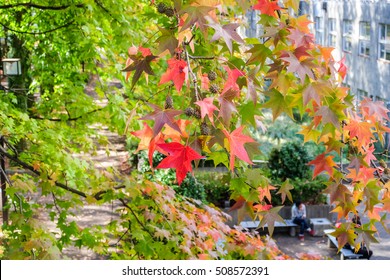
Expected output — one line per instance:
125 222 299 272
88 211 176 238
300 0 390 107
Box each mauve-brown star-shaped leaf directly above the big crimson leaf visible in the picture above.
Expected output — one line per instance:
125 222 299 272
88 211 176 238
140 103 182 136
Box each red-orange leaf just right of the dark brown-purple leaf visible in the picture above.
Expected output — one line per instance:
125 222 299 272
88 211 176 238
159 58 188 91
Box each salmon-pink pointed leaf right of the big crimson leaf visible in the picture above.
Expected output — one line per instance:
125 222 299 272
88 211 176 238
222 126 255 170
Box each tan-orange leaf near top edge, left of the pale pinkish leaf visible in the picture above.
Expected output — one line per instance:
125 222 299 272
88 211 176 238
179 6 215 33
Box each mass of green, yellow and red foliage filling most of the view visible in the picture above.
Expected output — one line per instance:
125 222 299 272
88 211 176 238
0 0 390 259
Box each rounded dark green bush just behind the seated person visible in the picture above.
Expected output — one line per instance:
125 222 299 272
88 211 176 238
268 142 310 182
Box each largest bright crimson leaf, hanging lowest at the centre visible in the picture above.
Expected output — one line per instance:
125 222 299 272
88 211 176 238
157 142 204 185
